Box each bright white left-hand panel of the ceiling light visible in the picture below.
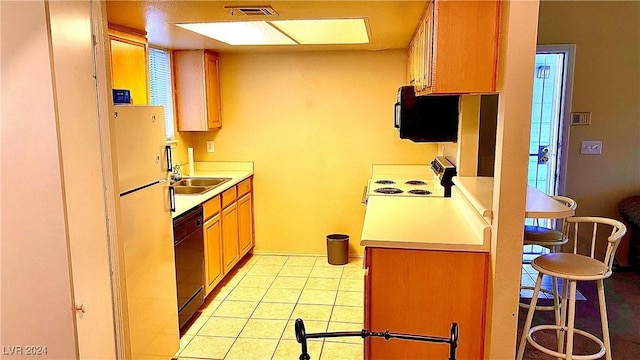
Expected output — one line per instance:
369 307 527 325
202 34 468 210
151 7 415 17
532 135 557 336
176 21 295 45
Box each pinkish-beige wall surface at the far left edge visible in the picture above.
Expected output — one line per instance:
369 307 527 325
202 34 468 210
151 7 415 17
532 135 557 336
0 1 77 359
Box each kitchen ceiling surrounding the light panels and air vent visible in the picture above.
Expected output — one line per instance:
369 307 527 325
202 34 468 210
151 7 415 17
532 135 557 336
107 0 426 52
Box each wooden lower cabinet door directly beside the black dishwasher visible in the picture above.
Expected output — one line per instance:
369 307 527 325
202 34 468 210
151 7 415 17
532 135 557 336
204 214 222 295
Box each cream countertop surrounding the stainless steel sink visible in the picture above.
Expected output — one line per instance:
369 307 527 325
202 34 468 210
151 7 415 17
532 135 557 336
171 162 253 218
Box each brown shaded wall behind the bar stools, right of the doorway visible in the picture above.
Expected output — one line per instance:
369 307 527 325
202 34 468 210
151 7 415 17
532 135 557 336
538 1 640 264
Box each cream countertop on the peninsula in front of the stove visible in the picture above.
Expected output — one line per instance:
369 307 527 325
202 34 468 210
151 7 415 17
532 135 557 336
360 196 490 252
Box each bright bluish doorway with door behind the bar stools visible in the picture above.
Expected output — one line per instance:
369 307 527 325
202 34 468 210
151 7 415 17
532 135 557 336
524 44 575 260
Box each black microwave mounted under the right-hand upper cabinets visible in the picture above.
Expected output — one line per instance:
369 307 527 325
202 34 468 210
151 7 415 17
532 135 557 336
394 86 460 142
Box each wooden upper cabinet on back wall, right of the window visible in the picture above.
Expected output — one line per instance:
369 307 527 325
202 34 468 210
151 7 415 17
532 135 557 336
173 50 222 131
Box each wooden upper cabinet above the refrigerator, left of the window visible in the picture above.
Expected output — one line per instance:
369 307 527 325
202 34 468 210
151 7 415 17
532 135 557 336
109 24 149 105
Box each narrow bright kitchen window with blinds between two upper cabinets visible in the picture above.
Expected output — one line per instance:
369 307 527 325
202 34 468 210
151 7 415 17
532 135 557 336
149 47 175 141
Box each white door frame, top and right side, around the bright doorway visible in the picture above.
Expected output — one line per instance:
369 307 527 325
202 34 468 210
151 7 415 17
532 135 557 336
536 44 576 195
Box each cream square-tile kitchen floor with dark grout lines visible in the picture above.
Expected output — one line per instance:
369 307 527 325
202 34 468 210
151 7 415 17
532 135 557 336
176 255 364 360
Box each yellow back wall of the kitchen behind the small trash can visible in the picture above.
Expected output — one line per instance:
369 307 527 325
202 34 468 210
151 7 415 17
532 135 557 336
194 51 437 254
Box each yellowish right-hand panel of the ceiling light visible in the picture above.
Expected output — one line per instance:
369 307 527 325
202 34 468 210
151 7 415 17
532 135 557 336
270 18 369 45
